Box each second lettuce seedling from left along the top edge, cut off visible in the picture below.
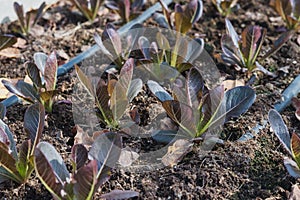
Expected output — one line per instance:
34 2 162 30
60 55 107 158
71 0 103 22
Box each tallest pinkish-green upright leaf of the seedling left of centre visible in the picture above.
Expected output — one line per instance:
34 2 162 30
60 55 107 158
110 58 134 120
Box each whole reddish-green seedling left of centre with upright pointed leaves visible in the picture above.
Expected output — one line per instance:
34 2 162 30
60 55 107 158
75 58 142 129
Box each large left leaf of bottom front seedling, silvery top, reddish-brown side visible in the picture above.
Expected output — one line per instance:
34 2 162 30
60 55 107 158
34 142 64 199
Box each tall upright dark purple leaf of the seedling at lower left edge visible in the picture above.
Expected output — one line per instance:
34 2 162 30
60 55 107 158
24 103 45 151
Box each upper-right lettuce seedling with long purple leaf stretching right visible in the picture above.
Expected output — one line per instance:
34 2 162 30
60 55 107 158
221 19 291 74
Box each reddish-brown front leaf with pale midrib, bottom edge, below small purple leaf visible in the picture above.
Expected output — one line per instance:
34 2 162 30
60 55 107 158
74 160 98 199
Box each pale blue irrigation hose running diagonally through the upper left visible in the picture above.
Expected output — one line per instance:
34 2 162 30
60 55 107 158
1 0 172 108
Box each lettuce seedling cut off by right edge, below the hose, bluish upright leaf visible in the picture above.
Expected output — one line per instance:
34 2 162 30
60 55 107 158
268 109 300 178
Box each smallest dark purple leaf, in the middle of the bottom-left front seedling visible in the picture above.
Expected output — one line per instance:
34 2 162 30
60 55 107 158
71 144 88 170
